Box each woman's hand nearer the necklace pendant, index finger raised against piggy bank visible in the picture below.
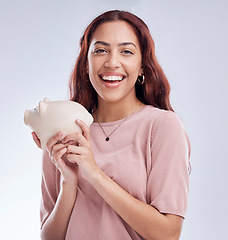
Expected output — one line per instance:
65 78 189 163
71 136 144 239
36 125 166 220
63 120 99 181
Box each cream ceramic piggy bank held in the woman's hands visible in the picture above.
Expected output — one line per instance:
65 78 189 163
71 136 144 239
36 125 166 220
24 98 93 150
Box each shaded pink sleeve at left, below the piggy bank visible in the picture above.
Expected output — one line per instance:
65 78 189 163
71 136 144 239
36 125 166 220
40 151 60 228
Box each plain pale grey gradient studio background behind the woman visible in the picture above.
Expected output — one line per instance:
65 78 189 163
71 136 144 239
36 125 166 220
0 0 228 240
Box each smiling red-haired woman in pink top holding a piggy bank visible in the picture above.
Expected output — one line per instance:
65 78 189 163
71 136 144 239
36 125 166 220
33 11 190 240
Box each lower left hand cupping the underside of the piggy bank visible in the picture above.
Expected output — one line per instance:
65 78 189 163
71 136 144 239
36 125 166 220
47 132 78 187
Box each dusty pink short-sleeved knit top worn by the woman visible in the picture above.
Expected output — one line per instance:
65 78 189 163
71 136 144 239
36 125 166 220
41 105 190 240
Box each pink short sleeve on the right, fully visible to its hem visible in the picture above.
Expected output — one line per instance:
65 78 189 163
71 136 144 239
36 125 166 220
147 111 191 218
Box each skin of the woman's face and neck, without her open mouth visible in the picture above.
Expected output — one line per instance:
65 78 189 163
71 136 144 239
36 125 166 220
87 21 143 122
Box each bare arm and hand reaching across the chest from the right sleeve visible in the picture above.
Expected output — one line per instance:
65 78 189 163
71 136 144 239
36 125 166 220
64 122 189 240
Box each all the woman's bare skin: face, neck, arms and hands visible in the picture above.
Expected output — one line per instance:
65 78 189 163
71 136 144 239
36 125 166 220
33 21 183 240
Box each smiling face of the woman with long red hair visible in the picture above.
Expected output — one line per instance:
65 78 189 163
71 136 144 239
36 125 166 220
87 20 142 105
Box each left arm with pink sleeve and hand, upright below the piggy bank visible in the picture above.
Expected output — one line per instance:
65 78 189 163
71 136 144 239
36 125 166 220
33 133 78 240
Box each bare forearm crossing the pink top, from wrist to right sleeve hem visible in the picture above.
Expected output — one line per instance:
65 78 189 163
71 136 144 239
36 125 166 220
91 171 183 240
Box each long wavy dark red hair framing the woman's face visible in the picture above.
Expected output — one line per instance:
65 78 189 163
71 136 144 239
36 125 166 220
69 10 173 113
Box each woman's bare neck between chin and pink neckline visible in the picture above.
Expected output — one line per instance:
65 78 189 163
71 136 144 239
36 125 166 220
93 99 144 122
